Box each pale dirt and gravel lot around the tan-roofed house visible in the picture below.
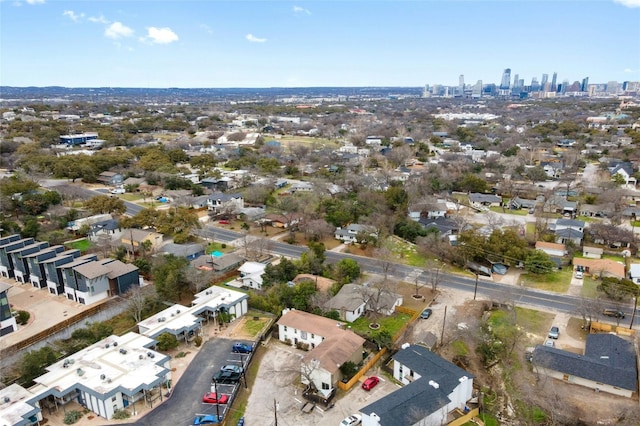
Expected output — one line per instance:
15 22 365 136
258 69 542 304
244 340 399 426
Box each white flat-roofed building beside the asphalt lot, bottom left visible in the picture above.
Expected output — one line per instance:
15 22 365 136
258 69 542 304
29 332 171 420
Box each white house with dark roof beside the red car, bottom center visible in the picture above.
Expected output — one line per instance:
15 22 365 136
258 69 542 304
360 345 477 426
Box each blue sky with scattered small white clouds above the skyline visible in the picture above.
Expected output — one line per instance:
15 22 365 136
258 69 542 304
0 0 640 88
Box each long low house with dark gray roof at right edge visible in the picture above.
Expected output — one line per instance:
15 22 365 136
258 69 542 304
532 333 638 398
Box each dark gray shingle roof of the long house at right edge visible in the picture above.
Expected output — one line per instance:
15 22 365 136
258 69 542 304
533 334 638 391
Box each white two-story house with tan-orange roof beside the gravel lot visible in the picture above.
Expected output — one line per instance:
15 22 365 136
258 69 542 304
278 309 365 398
